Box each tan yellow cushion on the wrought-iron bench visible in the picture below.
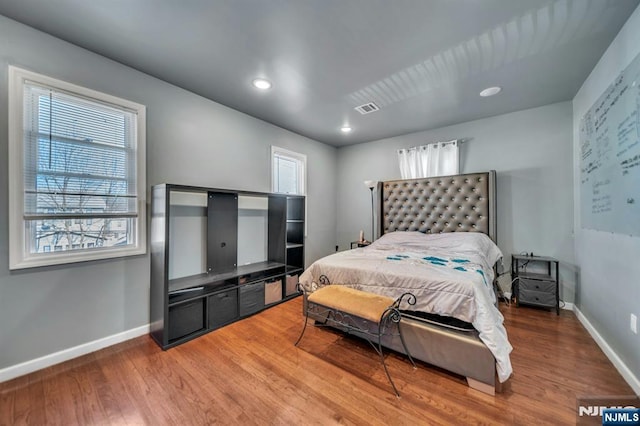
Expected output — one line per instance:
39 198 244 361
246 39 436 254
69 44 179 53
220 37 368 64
308 284 393 323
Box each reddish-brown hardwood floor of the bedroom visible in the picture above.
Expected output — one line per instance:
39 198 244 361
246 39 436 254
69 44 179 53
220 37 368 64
0 298 633 425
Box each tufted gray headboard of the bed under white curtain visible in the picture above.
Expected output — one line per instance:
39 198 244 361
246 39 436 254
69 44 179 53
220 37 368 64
378 170 497 242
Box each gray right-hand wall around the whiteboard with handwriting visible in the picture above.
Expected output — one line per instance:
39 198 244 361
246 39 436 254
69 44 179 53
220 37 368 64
573 8 640 392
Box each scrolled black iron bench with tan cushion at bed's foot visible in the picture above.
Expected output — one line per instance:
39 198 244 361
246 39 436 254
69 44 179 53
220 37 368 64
295 284 416 397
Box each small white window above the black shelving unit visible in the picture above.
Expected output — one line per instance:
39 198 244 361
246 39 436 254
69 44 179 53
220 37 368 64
271 146 307 195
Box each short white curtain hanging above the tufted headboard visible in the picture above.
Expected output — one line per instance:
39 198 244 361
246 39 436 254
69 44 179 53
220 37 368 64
398 140 460 179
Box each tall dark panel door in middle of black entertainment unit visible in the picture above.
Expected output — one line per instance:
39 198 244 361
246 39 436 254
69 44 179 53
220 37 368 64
207 192 238 272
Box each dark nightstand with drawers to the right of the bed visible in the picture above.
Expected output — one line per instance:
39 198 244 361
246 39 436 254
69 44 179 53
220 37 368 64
511 254 560 315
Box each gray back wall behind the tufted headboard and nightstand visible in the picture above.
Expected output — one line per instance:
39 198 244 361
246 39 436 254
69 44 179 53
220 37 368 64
337 99 575 302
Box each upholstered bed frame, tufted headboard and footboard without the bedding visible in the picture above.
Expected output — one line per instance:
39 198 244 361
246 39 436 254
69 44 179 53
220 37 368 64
378 170 501 395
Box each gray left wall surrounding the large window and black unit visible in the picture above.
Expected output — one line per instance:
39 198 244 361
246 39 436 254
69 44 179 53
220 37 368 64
0 16 336 370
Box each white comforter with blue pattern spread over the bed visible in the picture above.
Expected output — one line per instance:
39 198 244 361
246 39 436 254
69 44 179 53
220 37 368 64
300 232 512 382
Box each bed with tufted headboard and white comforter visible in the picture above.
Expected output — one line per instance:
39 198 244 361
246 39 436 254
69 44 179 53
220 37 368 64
300 171 512 394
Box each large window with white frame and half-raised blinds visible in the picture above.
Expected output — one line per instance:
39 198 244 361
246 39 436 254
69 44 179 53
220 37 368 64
9 67 146 269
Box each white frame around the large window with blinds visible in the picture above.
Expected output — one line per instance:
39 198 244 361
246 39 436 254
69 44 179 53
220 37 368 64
8 65 147 270
